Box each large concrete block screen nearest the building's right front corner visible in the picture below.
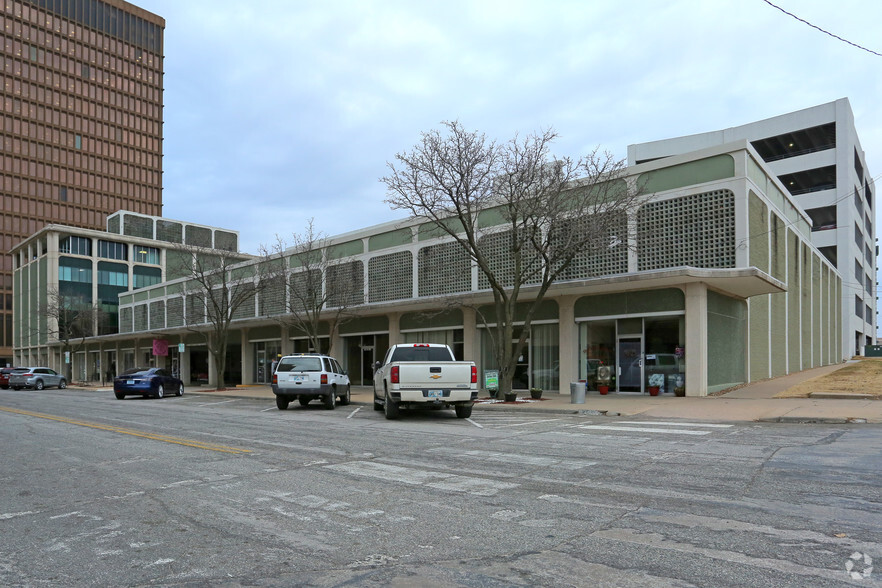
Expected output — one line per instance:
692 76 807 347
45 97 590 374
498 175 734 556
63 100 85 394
637 190 735 271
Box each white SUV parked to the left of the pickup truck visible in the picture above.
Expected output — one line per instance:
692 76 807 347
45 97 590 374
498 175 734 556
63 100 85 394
272 353 350 410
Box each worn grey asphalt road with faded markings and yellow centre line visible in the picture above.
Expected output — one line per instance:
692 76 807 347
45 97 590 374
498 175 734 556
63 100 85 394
0 390 882 587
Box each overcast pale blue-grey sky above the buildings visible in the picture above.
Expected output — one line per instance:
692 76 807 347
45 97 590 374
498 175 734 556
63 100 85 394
133 0 882 253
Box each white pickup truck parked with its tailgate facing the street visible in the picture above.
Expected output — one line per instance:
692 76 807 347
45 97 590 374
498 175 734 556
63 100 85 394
374 343 478 419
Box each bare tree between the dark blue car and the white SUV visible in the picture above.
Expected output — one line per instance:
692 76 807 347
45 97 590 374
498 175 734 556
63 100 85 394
173 244 284 389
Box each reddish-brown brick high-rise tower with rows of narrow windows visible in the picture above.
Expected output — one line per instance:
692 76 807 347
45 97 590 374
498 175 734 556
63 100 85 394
0 0 165 365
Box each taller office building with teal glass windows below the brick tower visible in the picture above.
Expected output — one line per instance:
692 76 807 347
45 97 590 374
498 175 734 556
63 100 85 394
13 211 244 381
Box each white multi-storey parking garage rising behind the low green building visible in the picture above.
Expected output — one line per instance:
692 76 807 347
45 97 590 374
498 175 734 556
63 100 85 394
628 98 878 357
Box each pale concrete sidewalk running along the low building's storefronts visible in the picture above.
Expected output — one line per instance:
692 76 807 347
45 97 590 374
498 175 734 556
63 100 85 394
175 364 882 423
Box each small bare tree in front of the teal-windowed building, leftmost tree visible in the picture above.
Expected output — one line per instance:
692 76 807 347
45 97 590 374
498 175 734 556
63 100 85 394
38 288 110 382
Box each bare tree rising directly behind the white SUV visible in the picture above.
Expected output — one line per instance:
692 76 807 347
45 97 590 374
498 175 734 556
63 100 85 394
276 219 364 352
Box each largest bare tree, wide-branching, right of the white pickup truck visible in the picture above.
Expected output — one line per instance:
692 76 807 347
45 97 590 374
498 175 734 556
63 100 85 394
381 121 640 393
